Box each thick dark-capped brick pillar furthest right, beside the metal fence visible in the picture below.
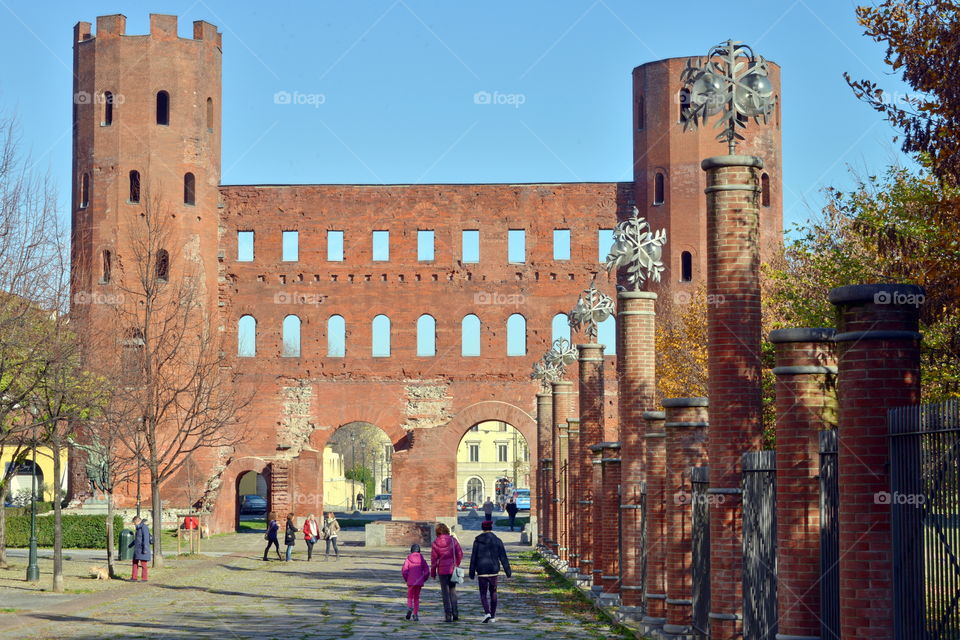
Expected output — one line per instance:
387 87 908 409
830 284 923 640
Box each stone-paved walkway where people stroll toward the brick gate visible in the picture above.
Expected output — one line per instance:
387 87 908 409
0 531 622 640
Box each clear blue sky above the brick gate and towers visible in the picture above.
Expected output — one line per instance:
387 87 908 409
0 0 904 235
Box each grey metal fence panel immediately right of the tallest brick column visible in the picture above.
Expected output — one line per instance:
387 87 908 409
742 451 777 640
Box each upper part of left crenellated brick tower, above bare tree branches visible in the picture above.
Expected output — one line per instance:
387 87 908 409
71 14 221 498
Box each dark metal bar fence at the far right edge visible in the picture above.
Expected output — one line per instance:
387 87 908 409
888 400 960 640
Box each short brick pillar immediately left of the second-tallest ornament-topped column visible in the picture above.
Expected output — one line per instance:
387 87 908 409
598 442 621 605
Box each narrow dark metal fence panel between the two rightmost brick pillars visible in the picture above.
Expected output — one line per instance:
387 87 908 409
820 429 840 640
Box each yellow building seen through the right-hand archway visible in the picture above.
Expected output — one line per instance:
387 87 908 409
457 421 530 506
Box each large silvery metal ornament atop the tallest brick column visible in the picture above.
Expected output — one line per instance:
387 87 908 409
680 40 777 155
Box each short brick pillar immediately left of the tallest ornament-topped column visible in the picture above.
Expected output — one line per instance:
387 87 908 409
663 398 708 640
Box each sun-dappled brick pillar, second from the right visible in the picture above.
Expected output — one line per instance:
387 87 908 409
770 329 837 638
